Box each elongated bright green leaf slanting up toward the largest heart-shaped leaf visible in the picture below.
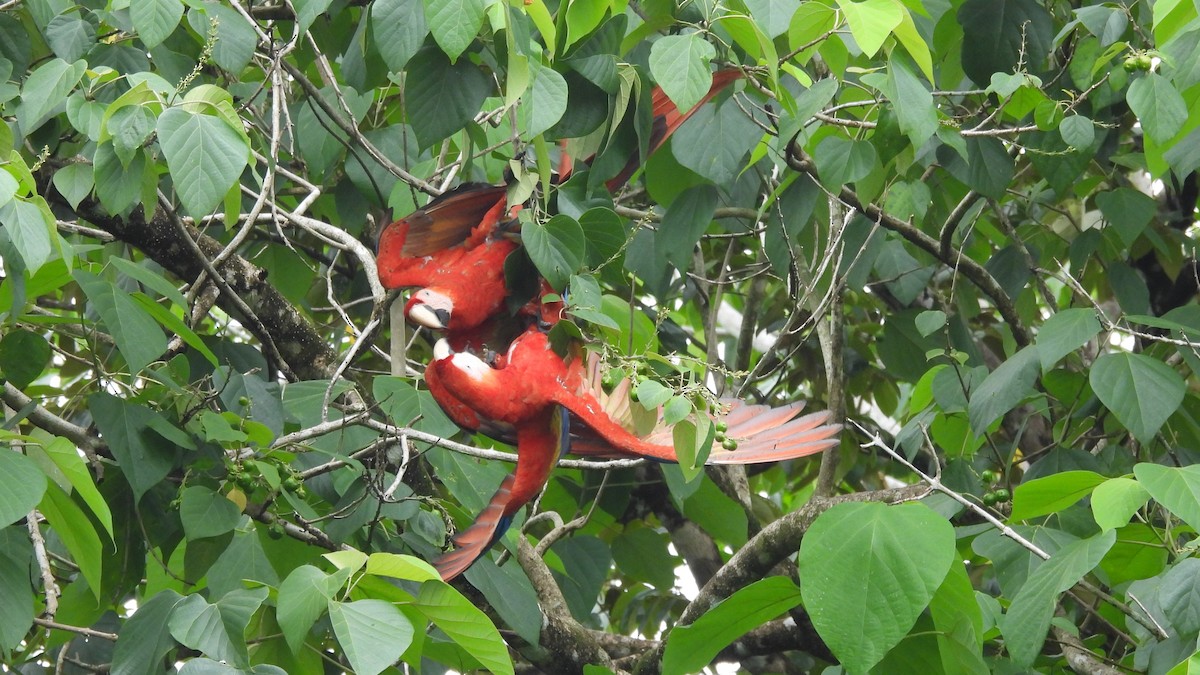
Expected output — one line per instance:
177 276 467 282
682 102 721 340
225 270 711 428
662 577 800 673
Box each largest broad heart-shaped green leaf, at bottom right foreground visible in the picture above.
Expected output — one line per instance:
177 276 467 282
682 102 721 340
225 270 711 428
799 503 955 673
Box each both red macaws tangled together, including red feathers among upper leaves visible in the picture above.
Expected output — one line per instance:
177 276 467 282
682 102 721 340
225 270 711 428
377 70 840 580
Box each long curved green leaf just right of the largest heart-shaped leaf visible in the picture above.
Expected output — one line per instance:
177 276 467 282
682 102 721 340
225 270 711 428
1000 530 1116 667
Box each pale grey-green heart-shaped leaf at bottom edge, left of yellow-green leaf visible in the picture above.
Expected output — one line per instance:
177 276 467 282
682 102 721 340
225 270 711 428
329 599 413 675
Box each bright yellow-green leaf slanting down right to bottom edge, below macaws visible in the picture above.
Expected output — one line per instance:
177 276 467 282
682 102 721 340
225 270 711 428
413 579 512 675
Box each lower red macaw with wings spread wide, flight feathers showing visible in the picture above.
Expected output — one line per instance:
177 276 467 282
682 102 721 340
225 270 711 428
426 327 841 580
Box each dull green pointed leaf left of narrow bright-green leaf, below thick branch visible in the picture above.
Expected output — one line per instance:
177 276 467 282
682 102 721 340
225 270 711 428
74 269 167 374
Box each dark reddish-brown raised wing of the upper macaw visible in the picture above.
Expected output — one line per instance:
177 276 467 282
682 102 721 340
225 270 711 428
401 183 508 258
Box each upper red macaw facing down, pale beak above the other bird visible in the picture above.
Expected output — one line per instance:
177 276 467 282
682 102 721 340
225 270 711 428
376 183 521 329
